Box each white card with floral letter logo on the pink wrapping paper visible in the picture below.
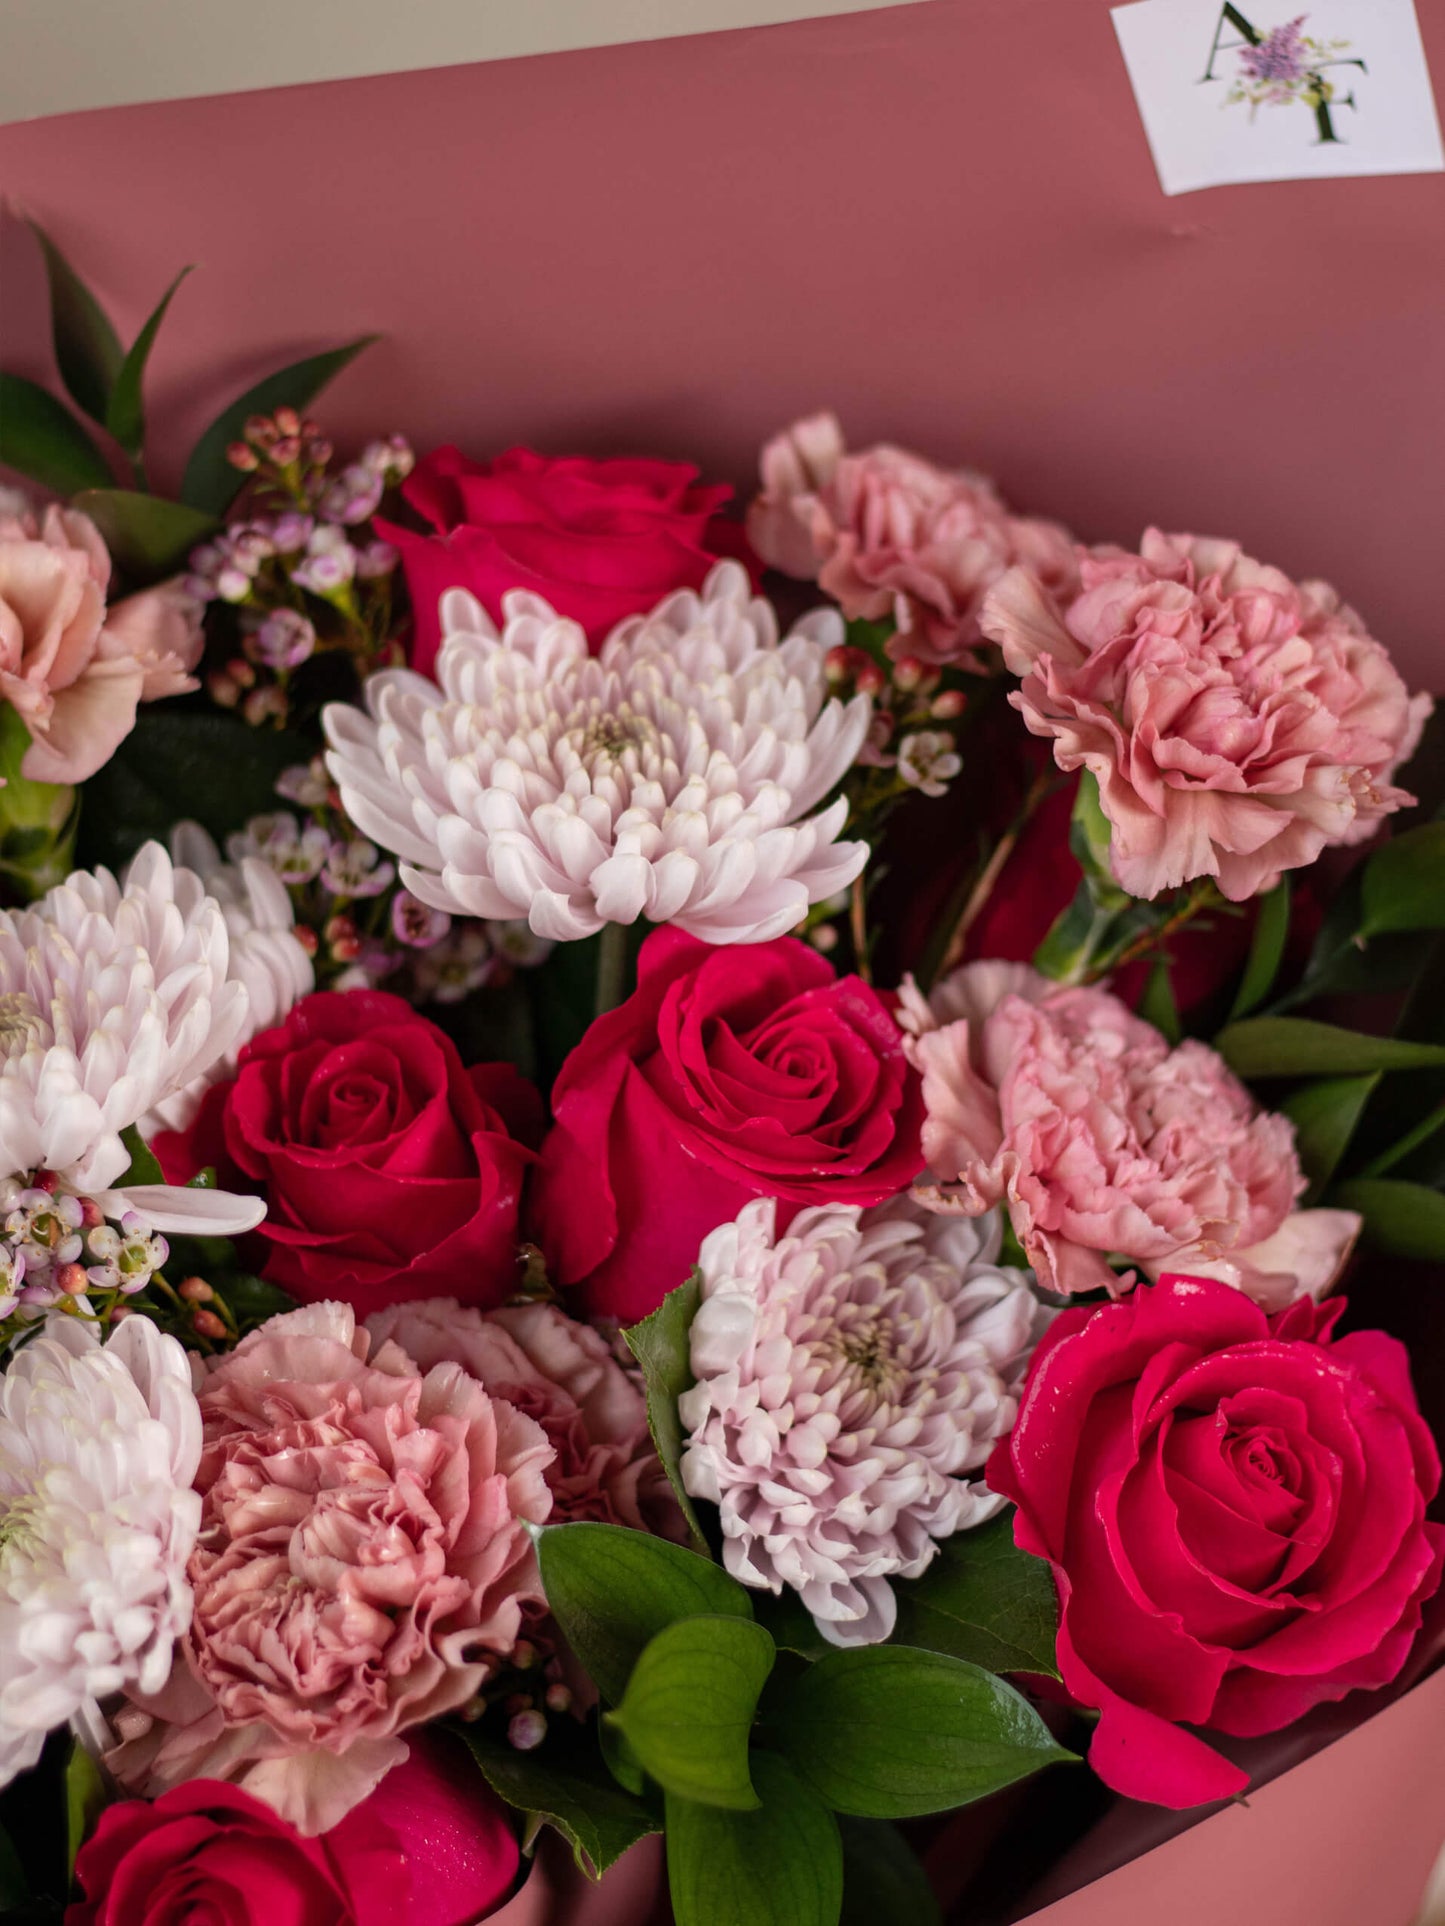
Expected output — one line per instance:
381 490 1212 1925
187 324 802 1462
1112 0 1445 195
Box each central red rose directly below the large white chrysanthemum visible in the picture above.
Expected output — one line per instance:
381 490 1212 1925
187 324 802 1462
536 928 923 1321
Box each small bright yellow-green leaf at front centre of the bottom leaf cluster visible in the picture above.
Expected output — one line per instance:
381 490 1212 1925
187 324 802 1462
607 1618 775 1810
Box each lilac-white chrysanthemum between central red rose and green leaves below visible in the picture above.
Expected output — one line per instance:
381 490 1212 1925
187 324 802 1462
678 1198 1048 1645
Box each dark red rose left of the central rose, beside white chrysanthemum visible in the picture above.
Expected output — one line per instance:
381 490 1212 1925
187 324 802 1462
154 990 539 1317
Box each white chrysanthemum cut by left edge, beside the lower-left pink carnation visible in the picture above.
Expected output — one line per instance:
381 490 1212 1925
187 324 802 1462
0 1317 200 1785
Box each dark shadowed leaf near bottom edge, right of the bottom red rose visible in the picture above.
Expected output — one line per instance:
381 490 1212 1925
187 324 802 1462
453 1720 663 1880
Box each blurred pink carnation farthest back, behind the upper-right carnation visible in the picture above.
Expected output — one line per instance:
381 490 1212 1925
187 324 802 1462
748 414 1079 670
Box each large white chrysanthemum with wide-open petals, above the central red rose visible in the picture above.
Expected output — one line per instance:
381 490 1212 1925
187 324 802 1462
324 562 871 944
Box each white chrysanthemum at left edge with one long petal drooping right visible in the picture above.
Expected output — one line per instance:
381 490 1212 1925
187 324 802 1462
0 844 262 1233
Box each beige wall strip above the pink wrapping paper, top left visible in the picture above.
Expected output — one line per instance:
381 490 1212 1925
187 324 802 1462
0 0 928 121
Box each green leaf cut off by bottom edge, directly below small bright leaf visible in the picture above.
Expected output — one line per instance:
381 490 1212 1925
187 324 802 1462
667 1753 843 1926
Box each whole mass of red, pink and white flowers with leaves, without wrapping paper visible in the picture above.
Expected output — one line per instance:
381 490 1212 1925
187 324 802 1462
0 237 1445 1926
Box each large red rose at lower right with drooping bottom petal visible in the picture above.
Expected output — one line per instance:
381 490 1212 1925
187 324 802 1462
988 1277 1445 1807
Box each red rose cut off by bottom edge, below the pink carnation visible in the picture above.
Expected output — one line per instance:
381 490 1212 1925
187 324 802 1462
66 1731 520 1926
